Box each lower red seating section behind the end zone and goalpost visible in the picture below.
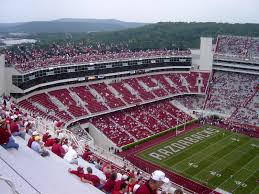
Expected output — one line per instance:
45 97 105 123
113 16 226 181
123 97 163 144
90 100 192 147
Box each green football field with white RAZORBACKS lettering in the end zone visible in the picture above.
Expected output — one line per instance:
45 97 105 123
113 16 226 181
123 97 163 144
138 126 259 194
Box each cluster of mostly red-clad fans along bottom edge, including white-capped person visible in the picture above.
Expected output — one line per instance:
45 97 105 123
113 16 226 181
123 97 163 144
68 163 183 194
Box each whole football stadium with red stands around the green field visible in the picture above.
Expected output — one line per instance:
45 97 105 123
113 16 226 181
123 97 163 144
0 35 259 194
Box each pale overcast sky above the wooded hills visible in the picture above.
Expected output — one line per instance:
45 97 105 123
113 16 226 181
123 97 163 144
0 0 259 23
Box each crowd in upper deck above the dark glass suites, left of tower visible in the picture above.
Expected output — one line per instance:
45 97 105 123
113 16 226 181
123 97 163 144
1 41 190 71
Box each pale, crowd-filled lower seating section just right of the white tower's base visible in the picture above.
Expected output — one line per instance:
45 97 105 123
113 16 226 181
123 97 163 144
205 71 259 115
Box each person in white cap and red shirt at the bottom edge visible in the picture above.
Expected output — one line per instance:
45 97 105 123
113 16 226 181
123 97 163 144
136 170 169 194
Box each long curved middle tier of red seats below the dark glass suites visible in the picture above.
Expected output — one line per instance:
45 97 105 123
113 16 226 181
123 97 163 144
19 72 209 124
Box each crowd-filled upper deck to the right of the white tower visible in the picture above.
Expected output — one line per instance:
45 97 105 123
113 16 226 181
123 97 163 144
215 36 259 58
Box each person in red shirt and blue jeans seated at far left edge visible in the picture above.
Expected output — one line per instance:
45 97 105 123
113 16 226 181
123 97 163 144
0 120 19 150
